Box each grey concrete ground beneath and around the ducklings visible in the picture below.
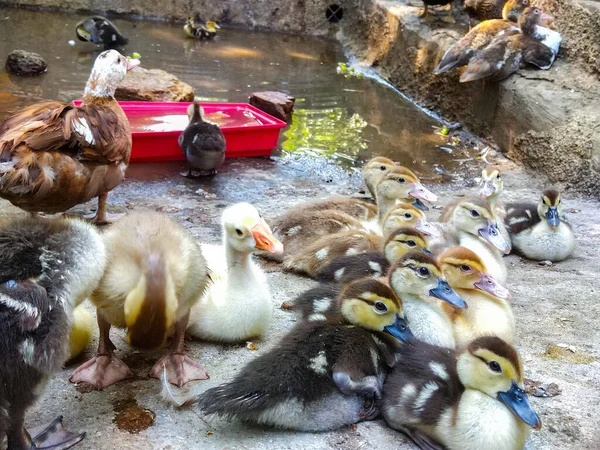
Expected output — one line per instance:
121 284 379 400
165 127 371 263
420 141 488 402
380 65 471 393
0 153 600 450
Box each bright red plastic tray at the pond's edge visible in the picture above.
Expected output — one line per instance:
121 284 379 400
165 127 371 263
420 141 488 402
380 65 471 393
73 100 286 162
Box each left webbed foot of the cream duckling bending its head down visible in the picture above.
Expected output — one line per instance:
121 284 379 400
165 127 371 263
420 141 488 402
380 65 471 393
69 353 133 390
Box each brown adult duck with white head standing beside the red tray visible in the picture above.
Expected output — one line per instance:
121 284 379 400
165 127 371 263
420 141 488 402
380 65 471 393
0 50 133 222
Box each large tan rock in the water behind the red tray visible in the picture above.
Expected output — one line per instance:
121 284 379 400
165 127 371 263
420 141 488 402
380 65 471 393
115 67 194 102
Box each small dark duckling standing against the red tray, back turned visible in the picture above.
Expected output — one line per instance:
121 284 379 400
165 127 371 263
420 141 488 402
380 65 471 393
179 102 225 177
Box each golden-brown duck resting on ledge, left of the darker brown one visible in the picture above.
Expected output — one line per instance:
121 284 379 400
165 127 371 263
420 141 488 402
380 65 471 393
434 0 531 75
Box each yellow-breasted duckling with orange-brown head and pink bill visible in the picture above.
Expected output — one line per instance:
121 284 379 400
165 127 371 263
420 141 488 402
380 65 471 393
438 247 516 349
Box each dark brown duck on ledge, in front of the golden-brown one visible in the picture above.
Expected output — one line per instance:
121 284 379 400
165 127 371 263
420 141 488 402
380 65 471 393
460 7 556 83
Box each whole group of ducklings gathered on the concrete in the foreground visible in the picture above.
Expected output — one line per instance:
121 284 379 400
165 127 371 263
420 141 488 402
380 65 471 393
0 157 574 450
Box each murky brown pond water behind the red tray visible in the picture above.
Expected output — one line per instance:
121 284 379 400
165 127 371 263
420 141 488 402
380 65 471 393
0 8 478 179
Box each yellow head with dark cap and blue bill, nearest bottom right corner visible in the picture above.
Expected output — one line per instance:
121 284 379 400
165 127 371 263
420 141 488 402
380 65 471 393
457 336 542 430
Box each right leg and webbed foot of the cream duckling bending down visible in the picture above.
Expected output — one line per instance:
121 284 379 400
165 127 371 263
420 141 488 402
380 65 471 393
150 313 209 387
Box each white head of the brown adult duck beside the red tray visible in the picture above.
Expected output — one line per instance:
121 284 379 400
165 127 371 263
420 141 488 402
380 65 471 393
85 50 140 97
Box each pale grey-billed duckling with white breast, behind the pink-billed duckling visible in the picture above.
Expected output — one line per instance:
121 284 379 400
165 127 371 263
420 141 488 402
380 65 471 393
430 196 511 283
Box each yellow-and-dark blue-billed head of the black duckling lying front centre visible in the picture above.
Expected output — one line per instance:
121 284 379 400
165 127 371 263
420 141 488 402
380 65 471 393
339 278 414 342
